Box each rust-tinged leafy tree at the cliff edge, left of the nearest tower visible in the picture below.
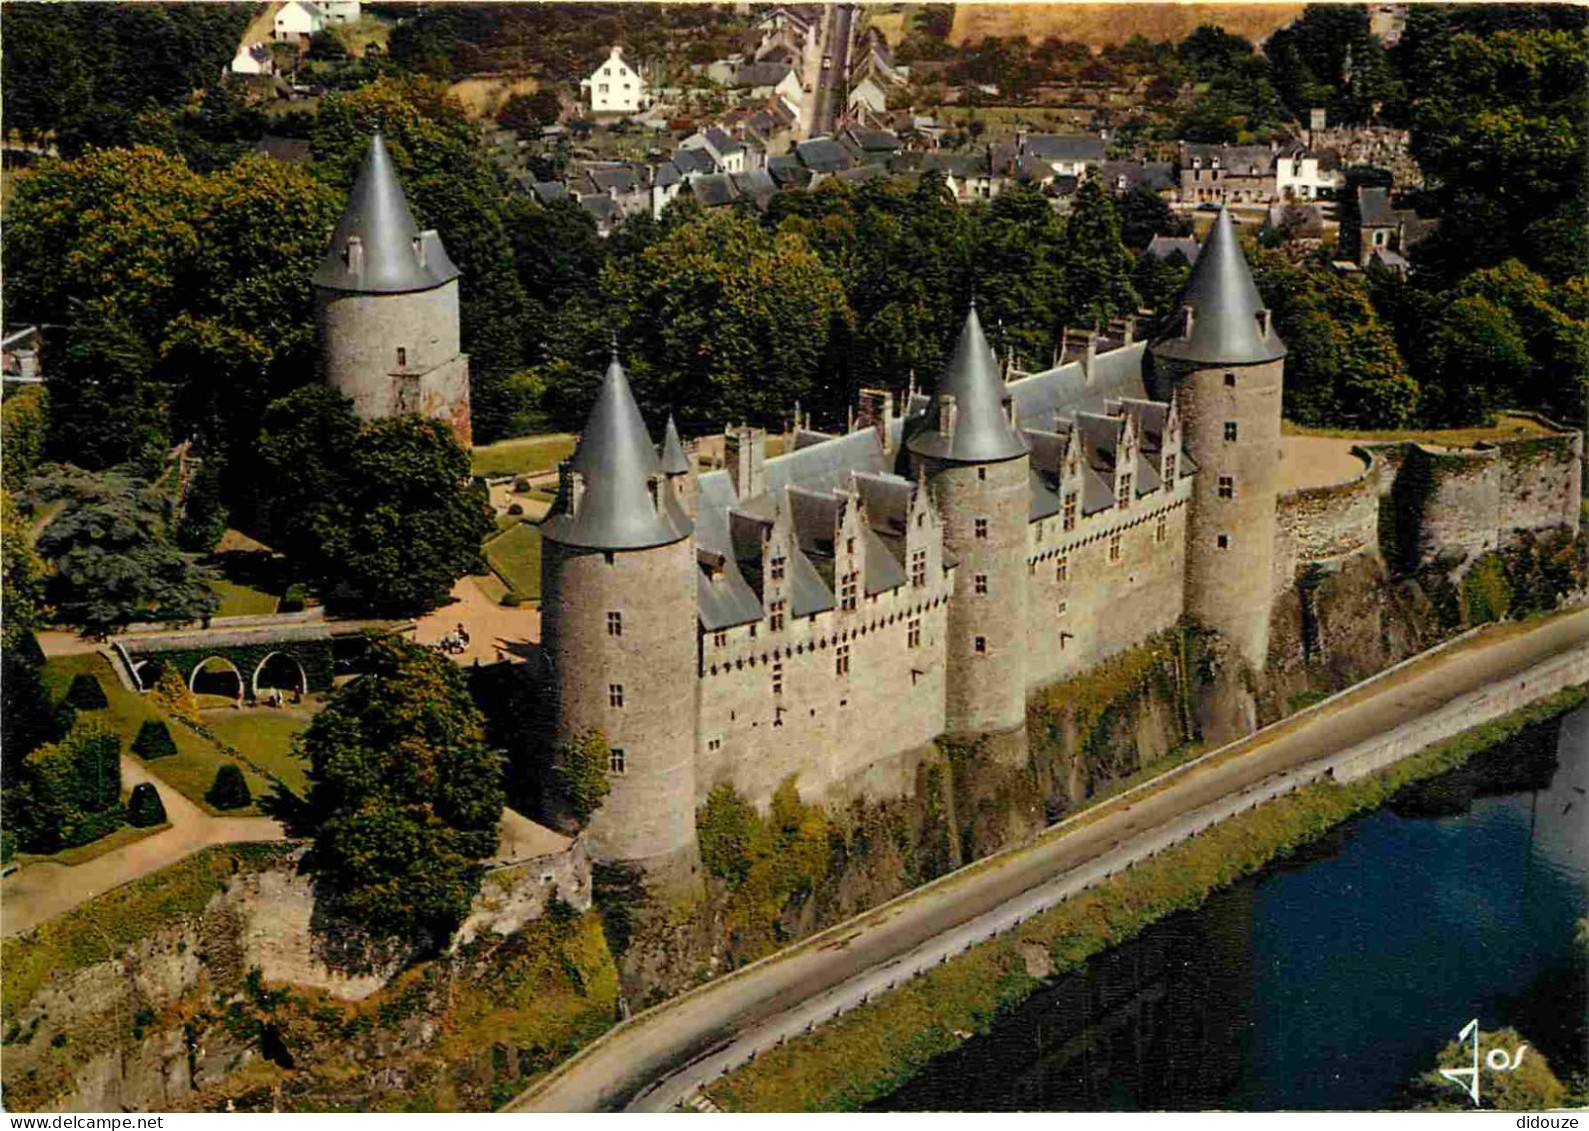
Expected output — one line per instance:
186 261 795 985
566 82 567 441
302 639 502 944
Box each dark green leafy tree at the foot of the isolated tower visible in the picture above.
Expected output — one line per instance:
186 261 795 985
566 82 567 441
259 388 493 615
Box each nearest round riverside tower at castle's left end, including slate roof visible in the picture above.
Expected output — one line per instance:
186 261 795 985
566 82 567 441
540 349 699 882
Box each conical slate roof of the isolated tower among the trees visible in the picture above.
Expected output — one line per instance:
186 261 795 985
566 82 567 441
313 133 459 294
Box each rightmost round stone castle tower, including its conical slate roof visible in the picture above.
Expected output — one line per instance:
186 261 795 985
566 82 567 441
1150 210 1286 669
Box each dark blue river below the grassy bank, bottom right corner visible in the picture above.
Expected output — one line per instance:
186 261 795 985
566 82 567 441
874 708 1589 1110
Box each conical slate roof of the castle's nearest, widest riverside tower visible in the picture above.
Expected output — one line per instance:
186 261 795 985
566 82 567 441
540 349 693 550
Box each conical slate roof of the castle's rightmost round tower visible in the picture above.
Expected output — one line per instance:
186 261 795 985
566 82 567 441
1152 208 1286 365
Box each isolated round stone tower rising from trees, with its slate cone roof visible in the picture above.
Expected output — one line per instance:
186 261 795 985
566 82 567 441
313 133 470 448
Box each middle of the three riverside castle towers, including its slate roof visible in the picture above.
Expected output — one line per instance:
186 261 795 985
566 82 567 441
906 302 1031 734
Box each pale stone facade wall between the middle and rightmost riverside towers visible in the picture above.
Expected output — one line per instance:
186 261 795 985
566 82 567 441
1026 477 1192 691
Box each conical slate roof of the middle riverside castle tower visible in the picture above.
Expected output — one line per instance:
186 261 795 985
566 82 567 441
906 300 1026 464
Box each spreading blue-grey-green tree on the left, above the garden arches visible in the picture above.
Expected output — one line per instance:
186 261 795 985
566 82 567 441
24 469 218 632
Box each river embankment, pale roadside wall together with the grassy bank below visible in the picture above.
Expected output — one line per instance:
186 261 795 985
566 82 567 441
695 648 1589 1110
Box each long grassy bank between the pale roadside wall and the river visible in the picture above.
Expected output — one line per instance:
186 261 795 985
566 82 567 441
707 688 1589 1112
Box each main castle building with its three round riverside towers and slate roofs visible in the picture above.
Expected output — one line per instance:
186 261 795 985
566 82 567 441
542 204 1286 875
